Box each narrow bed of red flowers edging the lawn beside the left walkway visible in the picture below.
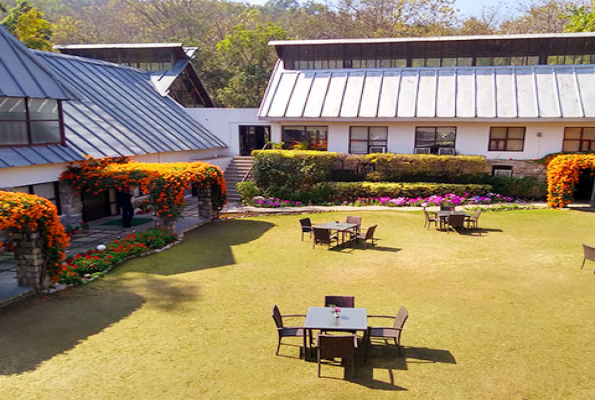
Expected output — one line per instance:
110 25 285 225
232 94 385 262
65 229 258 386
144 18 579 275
55 228 176 284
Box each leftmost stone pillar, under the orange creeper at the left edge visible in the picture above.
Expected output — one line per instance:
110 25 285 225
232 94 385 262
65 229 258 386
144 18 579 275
13 232 50 291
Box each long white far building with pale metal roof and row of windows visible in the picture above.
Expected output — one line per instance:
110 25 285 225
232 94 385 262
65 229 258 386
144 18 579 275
258 33 595 180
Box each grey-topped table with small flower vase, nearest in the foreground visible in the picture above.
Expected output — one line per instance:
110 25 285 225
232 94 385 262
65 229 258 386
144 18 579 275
304 307 368 360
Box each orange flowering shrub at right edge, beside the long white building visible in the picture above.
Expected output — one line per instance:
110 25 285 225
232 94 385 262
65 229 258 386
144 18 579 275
547 154 595 208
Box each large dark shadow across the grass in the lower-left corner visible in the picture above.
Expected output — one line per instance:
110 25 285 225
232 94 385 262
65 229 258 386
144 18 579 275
0 277 197 375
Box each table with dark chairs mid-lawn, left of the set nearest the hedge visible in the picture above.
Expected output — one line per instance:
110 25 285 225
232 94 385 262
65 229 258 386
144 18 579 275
300 216 378 249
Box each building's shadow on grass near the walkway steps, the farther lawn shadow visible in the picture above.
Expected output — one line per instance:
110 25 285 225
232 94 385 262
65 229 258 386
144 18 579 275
126 219 275 276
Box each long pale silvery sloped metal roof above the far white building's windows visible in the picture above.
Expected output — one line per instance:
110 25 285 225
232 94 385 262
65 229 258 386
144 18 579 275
259 61 595 120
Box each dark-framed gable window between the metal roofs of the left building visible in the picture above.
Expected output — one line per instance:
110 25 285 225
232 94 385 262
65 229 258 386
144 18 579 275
0 97 64 146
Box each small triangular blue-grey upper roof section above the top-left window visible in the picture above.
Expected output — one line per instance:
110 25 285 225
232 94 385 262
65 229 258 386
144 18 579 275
0 26 76 100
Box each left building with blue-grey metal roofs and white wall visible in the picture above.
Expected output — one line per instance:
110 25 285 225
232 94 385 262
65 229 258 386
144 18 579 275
0 27 227 224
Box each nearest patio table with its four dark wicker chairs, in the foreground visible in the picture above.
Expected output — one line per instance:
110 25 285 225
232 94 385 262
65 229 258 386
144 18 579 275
272 296 409 377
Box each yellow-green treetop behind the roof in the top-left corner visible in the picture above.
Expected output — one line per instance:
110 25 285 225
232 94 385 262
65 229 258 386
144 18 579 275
1 0 52 50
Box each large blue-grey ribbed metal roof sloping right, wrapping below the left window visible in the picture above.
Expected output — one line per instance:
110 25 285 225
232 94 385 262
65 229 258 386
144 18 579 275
0 52 226 167
